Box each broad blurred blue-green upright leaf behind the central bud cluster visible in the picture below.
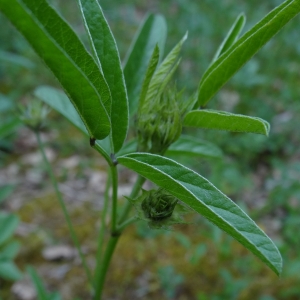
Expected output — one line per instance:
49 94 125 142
124 14 167 116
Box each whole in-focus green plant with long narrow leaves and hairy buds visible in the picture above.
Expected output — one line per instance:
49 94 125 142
0 0 300 299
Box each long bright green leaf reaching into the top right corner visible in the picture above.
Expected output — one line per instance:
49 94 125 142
198 0 300 106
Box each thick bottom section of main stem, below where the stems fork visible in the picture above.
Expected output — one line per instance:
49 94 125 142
94 236 120 300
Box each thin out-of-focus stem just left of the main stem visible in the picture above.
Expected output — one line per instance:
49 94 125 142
94 174 111 288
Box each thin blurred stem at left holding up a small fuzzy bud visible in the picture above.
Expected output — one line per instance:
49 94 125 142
35 131 93 285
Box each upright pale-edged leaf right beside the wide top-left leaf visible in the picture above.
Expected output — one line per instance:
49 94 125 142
79 0 128 152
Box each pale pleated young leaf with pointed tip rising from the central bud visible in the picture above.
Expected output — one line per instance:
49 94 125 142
144 34 187 104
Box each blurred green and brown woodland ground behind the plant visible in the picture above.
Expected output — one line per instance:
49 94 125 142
0 0 300 300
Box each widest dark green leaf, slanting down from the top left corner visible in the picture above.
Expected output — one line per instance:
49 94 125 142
0 0 111 139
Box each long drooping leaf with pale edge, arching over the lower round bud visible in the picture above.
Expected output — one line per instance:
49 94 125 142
118 153 282 274
